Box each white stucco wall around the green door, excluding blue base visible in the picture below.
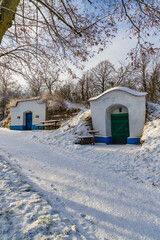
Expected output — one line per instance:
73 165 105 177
90 89 146 138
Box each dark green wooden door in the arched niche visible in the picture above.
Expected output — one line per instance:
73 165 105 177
111 113 129 144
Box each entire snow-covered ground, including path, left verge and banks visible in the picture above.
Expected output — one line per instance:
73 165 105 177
0 104 160 240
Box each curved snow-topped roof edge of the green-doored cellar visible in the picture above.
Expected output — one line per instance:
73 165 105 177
89 87 147 101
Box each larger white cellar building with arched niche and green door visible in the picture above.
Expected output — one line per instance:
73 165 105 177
90 87 147 144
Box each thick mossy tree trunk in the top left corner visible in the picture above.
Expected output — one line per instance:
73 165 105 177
0 0 20 43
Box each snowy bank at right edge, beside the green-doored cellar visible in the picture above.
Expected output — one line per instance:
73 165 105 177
127 102 160 187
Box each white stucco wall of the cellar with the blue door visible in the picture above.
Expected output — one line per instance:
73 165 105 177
11 100 46 126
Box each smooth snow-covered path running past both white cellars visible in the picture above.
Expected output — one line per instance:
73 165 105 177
0 130 160 240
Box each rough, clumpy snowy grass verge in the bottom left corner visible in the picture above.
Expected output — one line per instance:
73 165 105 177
0 156 82 240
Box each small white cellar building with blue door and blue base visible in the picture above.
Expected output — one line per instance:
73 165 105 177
10 98 46 130
